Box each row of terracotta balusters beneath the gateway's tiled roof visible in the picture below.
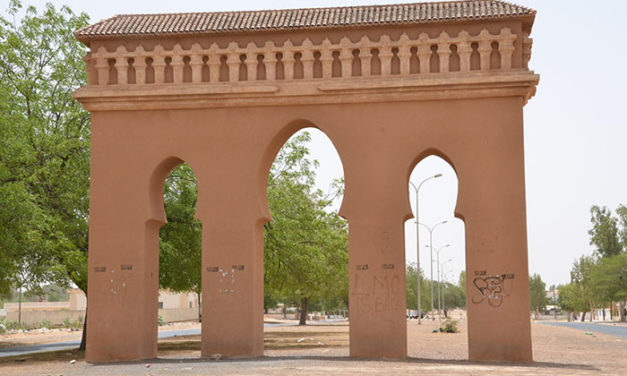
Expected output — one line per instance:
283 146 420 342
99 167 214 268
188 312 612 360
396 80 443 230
87 28 520 85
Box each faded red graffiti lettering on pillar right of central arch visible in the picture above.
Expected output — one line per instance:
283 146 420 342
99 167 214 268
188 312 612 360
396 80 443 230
351 273 402 313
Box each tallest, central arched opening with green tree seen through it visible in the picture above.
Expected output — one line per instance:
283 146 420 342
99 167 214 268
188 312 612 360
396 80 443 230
264 128 348 356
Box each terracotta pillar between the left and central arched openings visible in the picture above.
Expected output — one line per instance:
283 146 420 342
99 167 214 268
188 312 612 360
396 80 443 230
201 213 263 357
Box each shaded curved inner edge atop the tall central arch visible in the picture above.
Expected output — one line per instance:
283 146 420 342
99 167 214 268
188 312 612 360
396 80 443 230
257 119 346 223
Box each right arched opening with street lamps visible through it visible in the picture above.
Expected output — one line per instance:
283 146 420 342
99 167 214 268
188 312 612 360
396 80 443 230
405 155 467 359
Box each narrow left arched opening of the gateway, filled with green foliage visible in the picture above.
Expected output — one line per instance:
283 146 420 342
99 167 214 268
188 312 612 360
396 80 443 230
158 163 202 357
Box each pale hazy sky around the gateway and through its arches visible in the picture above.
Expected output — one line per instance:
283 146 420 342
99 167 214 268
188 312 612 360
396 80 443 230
13 0 627 286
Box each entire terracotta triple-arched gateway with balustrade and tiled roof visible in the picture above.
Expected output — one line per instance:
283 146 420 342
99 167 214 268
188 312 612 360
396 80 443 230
75 0 539 362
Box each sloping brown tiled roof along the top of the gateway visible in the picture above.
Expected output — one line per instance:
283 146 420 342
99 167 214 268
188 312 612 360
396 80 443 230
75 0 535 40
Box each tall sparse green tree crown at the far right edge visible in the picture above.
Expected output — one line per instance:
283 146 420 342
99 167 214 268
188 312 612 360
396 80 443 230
588 205 622 257
